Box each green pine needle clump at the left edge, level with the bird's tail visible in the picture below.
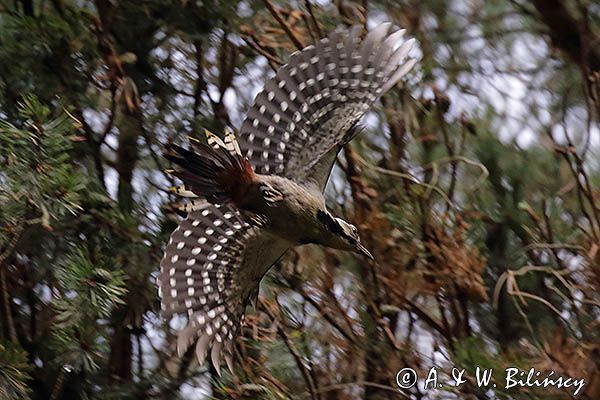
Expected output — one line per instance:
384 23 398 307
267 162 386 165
0 96 87 233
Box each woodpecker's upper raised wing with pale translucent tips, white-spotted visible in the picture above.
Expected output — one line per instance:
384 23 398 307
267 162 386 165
239 24 416 190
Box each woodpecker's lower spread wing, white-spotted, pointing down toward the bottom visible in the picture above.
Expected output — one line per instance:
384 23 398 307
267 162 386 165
158 200 288 371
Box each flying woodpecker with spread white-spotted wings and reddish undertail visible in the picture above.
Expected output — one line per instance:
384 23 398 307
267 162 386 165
157 23 416 375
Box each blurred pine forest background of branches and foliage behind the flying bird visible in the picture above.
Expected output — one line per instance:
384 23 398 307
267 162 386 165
0 0 600 400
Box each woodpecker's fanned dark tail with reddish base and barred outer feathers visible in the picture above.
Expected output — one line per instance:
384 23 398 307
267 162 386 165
164 129 254 203
